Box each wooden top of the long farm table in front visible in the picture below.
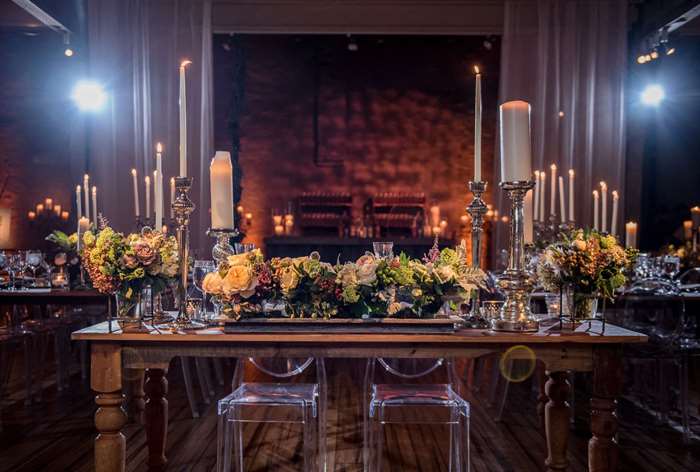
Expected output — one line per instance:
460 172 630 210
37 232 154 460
72 321 647 345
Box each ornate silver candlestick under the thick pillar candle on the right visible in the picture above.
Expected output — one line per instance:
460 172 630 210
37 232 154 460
491 181 538 332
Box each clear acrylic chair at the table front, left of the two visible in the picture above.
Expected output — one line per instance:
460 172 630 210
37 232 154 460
216 357 326 472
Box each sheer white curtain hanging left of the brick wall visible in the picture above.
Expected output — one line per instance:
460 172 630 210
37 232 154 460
88 0 214 254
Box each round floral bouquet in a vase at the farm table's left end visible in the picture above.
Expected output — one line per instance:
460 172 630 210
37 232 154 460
82 226 179 328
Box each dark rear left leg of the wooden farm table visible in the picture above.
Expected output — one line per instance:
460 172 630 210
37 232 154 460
144 369 168 472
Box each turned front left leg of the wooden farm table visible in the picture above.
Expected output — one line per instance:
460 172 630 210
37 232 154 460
90 343 126 472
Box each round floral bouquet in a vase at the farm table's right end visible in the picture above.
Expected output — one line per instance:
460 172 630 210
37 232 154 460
537 229 636 319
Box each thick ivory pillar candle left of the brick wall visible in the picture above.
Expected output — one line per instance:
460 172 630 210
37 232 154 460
209 151 233 229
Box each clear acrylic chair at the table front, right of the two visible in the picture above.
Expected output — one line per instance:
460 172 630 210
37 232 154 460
363 358 470 472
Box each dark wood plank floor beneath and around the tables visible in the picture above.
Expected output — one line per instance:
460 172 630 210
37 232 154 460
0 360 700 472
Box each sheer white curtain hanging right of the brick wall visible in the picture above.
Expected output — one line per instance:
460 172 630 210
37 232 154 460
495 0 627 260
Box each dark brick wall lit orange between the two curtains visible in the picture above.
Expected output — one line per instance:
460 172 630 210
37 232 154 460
215 35 499 249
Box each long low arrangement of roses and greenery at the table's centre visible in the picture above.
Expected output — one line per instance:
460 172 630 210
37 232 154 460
203 246 485 319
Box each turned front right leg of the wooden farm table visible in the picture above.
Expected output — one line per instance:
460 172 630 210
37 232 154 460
588 347 622 472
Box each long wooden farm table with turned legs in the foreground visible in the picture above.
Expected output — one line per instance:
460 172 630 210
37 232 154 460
73 322 647 472
